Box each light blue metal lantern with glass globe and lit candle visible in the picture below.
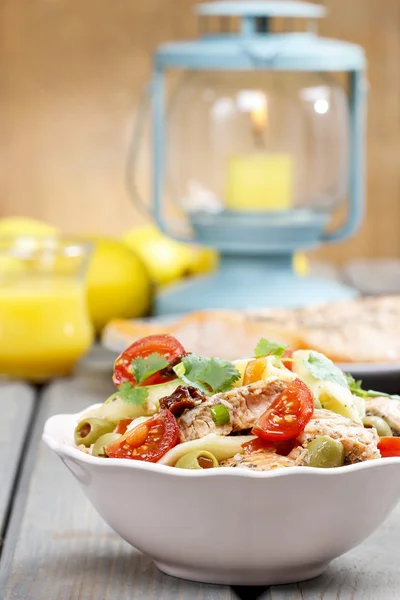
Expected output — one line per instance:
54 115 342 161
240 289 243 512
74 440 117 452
130 0 366 314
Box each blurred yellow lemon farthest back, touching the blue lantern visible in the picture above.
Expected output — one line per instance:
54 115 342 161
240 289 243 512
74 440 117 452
122 225 218 286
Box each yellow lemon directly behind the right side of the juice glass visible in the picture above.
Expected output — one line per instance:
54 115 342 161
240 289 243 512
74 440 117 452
87 239 152 333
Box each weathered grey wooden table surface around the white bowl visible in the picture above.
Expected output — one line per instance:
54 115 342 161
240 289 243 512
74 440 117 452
0 358 400 600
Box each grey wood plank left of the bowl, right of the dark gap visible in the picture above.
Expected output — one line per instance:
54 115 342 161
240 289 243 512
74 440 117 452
0 373 233 600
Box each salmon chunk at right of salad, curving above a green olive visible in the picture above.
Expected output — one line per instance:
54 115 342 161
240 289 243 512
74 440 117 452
297 408 381 464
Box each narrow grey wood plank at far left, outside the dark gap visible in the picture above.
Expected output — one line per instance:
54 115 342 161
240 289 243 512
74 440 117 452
0 382 35 545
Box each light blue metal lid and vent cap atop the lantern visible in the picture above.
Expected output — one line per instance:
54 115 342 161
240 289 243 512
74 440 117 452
155 0 366 72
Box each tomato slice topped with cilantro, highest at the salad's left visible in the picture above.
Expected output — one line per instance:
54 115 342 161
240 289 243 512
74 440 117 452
113 334 185 386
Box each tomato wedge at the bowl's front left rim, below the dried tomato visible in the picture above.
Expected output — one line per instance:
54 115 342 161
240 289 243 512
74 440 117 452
105 409 179 462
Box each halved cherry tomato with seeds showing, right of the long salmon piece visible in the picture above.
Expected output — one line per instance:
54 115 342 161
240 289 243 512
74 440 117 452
252 379 314 442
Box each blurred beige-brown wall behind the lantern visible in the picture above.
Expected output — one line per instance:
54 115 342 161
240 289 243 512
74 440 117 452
0 0 400 261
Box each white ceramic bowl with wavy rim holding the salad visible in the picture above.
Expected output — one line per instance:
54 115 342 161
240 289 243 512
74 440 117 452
43 404 400 585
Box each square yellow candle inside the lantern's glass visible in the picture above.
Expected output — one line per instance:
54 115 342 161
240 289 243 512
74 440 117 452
226 153 293 211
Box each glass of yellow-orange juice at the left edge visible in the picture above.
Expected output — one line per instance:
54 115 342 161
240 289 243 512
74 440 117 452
0 236 93 382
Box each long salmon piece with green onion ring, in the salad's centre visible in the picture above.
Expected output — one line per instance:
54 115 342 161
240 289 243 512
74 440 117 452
177 379 287 442
